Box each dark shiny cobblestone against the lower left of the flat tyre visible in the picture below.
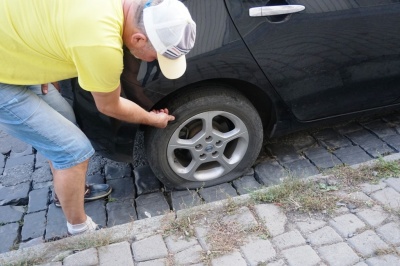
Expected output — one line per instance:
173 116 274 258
133 165 162 195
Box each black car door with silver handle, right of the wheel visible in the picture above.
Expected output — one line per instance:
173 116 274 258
225 0 400 121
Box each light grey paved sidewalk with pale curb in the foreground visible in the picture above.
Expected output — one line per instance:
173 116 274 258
0 154 400 266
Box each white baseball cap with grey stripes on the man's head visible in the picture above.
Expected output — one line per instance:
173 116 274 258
143 0 196 79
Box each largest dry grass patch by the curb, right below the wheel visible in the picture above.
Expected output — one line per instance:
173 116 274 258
251 178 340 212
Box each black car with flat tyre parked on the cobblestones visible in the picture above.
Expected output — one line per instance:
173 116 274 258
74 0 400 189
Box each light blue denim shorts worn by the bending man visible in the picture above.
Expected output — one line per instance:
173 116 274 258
0 83 94 169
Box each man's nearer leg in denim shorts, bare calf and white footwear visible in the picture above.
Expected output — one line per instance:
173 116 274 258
0 83 96 234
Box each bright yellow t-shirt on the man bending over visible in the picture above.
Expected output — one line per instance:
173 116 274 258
0 0 124 92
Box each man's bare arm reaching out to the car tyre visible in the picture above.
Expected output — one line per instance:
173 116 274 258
92 86 175 128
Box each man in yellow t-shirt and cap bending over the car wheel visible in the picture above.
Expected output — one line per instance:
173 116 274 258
0 0 196 235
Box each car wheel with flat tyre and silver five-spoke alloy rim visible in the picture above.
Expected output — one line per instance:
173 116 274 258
145 87 263 189
